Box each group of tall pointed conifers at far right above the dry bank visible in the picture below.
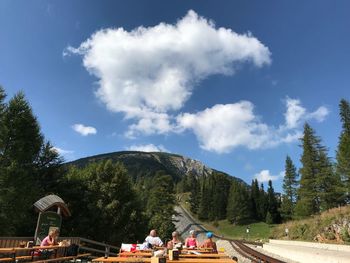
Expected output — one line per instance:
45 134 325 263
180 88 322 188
281 99 350 220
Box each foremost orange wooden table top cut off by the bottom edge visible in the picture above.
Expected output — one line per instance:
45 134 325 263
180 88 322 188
92 257 236 263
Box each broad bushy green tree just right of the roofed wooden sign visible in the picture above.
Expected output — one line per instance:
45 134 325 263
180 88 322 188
62 160 147 243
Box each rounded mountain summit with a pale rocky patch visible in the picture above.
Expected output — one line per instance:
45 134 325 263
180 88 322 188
66 151 243 182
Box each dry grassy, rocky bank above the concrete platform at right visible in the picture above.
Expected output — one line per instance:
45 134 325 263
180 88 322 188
272 206 350 244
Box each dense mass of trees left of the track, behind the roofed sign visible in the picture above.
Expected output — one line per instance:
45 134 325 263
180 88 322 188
0 87 175 243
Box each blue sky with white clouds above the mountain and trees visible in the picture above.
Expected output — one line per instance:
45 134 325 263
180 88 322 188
0 0 350 191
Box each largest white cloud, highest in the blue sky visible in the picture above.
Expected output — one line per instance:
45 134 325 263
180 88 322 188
63 10 271 136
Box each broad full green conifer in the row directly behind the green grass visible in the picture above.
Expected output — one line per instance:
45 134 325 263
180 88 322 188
227 181 251 224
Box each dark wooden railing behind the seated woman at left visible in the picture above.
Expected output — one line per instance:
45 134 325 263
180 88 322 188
0 237 119 257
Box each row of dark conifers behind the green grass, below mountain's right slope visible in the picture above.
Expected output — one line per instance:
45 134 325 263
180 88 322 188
177 171 281 224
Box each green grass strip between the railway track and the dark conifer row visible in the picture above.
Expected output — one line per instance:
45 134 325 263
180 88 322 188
178 193 275 241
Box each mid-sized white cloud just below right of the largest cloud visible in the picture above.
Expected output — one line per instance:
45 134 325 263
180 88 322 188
177 101 272 153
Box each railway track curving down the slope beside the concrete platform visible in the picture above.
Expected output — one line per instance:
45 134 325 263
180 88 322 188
175 206 286 263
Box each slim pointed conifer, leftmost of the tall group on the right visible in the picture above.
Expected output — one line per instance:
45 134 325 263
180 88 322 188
281 156 298 220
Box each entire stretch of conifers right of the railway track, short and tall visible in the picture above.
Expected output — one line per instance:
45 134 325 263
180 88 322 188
177 99 350 224
